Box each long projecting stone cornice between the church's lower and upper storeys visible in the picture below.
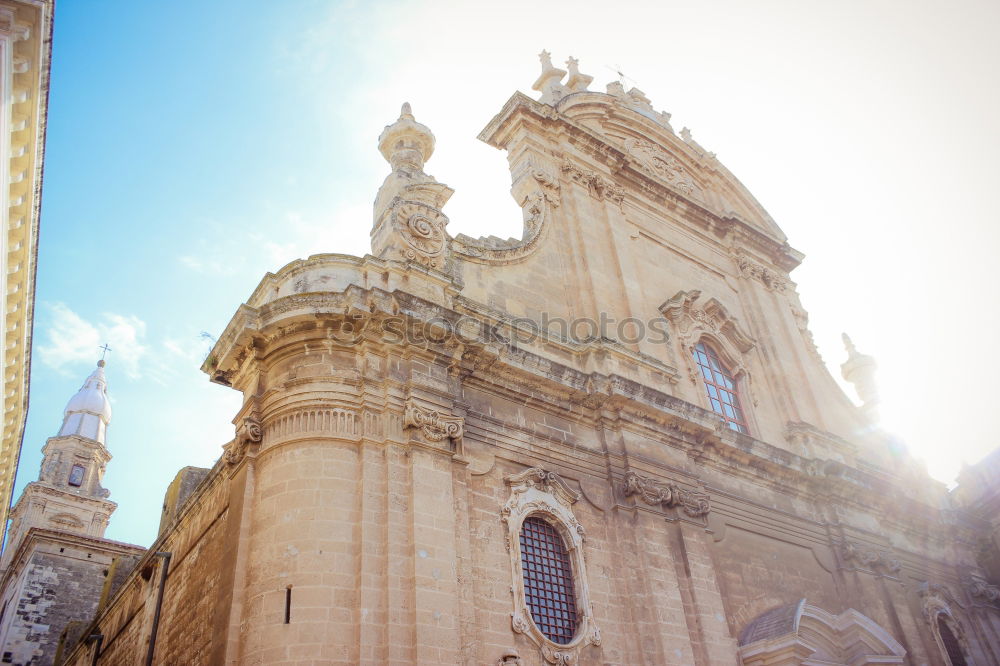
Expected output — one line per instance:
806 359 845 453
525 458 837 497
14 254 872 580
206 285 944 514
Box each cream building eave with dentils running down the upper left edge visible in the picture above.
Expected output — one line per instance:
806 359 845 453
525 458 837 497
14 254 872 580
0 0 54 538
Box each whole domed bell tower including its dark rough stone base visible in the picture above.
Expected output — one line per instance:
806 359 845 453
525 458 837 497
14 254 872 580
0 360 145 666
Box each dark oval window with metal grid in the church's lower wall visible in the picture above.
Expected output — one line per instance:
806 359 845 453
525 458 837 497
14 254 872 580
520 516 580 645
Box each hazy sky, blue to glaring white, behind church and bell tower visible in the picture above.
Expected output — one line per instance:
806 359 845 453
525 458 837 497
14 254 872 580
15 0 1000 545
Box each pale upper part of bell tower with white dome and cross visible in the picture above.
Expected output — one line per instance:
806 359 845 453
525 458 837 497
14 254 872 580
4 360 117 566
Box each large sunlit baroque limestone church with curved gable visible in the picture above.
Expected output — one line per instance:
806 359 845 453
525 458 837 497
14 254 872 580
29 53 1000 666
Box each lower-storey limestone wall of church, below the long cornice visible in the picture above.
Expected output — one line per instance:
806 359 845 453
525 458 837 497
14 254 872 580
60 328 998 666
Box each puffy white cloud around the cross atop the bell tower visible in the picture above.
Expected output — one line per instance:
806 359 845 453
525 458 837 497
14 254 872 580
37 303 150 379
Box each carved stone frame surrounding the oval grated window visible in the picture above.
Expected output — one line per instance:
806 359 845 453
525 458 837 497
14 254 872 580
500 467 601 666
